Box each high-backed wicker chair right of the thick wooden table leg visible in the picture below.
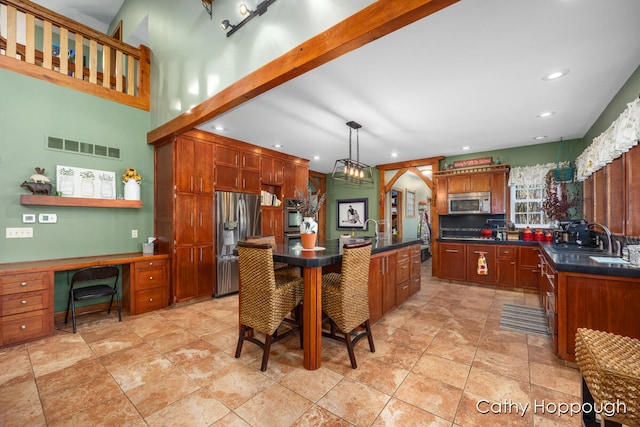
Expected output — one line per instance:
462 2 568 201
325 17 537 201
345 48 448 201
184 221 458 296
322 242 376 369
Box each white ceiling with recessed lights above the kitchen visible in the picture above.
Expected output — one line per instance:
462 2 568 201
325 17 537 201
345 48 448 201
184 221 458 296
37 0 640 173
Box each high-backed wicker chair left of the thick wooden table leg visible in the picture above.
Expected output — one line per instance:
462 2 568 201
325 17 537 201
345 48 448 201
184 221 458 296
236 241 304 372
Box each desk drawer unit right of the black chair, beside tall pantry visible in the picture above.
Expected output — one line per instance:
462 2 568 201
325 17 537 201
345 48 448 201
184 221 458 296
122 259 170 315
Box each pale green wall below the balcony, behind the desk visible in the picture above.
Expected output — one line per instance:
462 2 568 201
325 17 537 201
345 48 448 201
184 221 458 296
0 69 154 311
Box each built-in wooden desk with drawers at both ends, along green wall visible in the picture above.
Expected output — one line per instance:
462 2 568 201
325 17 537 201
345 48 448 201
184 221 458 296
0 252 169 346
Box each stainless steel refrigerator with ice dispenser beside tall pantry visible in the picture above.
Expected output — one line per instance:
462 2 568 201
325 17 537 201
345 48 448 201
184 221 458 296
214 191 261 297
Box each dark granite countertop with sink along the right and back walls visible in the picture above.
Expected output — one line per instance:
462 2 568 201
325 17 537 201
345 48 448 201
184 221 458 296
438 238 640 278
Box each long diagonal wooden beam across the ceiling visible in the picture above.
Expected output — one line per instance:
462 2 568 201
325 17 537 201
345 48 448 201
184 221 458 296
147 0 459 144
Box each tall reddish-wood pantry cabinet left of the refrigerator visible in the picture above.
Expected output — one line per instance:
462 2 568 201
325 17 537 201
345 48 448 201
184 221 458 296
154 131 215 303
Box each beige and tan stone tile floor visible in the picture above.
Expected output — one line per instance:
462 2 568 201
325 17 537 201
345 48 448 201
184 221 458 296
0 261 581 427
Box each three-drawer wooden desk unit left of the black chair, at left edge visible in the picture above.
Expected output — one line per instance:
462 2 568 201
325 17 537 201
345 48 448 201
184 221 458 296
0 272 53 346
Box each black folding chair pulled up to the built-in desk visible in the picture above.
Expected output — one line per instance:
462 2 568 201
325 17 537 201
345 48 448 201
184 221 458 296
64 266 122 334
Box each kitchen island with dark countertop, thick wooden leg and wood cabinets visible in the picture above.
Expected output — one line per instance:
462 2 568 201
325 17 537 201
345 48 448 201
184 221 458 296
273 238 420 370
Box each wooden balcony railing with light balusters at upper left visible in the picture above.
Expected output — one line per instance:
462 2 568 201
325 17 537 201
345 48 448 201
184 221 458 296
0 0 150 111
